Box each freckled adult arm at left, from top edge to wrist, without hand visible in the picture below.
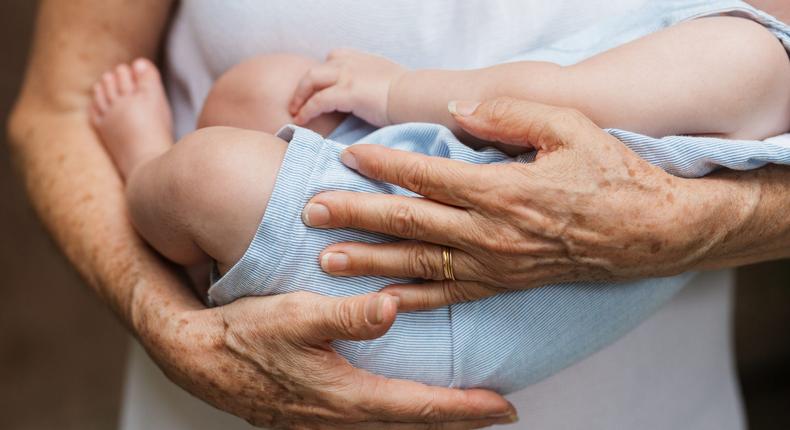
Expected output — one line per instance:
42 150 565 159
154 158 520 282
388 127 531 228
9 0 179 324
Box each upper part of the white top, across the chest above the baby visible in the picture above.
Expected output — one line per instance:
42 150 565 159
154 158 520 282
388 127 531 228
167 0 660 136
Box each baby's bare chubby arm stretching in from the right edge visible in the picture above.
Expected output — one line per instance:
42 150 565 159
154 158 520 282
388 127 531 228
295 17 790 138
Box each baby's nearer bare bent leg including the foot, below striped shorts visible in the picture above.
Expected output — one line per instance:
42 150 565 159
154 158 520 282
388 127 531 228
92 61 285 270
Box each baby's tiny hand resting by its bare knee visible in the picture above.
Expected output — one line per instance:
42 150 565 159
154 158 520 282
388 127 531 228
288 49 406 127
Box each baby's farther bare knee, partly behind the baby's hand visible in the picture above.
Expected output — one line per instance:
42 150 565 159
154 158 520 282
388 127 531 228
198 54 346 136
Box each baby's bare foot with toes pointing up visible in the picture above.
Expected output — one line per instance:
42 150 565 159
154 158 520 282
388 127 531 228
91 59 173 178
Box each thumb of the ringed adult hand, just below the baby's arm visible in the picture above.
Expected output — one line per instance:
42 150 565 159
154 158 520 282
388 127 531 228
447 97 600 151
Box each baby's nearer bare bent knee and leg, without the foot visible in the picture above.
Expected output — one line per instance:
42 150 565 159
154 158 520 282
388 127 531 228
126 127 286 273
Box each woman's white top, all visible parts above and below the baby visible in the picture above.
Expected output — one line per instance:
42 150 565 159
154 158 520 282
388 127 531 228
121 0 744 430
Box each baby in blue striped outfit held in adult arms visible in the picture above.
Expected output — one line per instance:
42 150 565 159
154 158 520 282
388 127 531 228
91 16 790 392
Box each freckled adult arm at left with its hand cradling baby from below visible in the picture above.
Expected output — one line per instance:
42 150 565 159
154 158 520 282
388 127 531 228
9 0 514 428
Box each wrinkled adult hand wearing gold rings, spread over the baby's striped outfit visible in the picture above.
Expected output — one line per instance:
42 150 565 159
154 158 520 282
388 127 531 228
303 98 754 309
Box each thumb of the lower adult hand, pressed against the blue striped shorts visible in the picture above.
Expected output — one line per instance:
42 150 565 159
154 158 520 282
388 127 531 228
300 293 398 344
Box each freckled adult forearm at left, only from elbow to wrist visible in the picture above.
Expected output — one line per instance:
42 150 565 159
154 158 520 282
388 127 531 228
10 107 201 325
